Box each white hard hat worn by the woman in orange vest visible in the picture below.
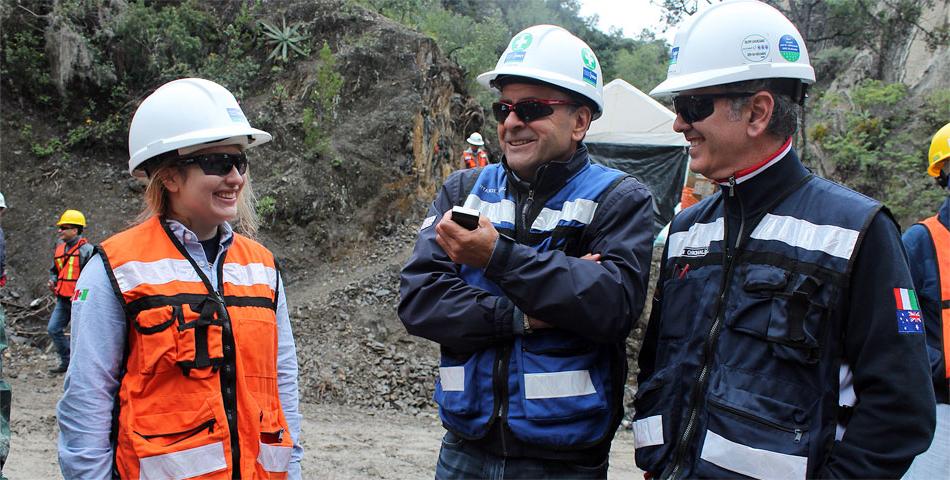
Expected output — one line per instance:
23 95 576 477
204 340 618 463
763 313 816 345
129 78 271 177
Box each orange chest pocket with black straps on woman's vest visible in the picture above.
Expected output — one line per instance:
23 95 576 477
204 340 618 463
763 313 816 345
132 299 226 378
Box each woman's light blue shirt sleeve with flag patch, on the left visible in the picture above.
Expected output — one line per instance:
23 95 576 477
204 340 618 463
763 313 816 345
56 255 126 480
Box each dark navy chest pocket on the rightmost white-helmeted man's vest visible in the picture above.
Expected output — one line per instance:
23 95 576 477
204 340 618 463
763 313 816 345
725 264 834 366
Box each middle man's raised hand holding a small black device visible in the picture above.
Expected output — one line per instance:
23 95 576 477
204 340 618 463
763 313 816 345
435 210 498 268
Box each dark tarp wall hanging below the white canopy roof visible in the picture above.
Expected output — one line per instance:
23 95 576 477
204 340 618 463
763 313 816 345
587 143 689 236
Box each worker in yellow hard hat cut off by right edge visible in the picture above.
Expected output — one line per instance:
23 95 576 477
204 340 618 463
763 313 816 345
902 123 950 479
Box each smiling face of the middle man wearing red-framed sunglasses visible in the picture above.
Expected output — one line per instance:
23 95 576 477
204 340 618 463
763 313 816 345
498 83 591 180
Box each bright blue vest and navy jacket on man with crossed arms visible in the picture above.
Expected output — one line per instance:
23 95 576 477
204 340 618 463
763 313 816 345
399 145 652 459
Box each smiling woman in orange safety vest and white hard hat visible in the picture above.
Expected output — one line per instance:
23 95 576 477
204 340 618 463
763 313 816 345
57 78 303 479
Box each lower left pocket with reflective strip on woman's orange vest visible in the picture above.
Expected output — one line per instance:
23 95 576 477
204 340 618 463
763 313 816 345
130 402 228 479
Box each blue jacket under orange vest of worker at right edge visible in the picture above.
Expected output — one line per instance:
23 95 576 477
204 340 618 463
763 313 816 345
903 197 950 403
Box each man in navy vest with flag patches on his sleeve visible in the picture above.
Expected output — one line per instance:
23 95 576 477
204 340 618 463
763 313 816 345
633 0 934 479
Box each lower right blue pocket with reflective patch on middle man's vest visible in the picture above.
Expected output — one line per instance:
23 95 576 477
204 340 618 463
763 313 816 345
516 331 608 423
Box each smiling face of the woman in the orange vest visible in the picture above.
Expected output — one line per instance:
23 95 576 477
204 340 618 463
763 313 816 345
163 145 246 240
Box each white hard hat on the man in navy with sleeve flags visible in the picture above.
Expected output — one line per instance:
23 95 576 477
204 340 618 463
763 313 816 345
650 0 815 97
